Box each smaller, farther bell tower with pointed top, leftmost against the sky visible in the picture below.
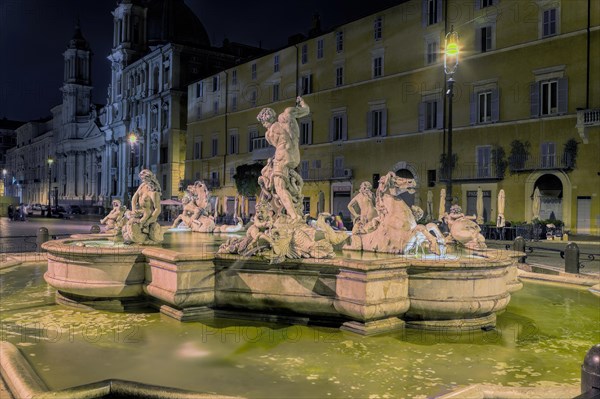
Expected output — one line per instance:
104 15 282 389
60 20 92 124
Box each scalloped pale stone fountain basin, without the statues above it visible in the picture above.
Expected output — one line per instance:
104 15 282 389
43 236 523 335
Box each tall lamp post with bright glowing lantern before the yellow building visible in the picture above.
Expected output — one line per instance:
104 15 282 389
443 26 459 209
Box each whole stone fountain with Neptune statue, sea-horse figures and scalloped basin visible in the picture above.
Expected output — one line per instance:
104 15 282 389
38 97 522 335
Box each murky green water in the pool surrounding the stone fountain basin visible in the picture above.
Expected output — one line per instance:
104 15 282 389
0 265 600 399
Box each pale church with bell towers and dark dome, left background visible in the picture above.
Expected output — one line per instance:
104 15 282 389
7 0 256 206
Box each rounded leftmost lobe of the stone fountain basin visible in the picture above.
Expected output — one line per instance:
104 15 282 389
42 235 146 299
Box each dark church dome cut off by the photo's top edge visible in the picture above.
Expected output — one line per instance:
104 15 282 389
144 0 210 47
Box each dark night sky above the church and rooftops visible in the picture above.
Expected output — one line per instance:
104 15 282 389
0 0 401 121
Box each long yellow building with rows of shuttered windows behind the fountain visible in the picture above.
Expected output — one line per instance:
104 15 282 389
185 0 600 235
